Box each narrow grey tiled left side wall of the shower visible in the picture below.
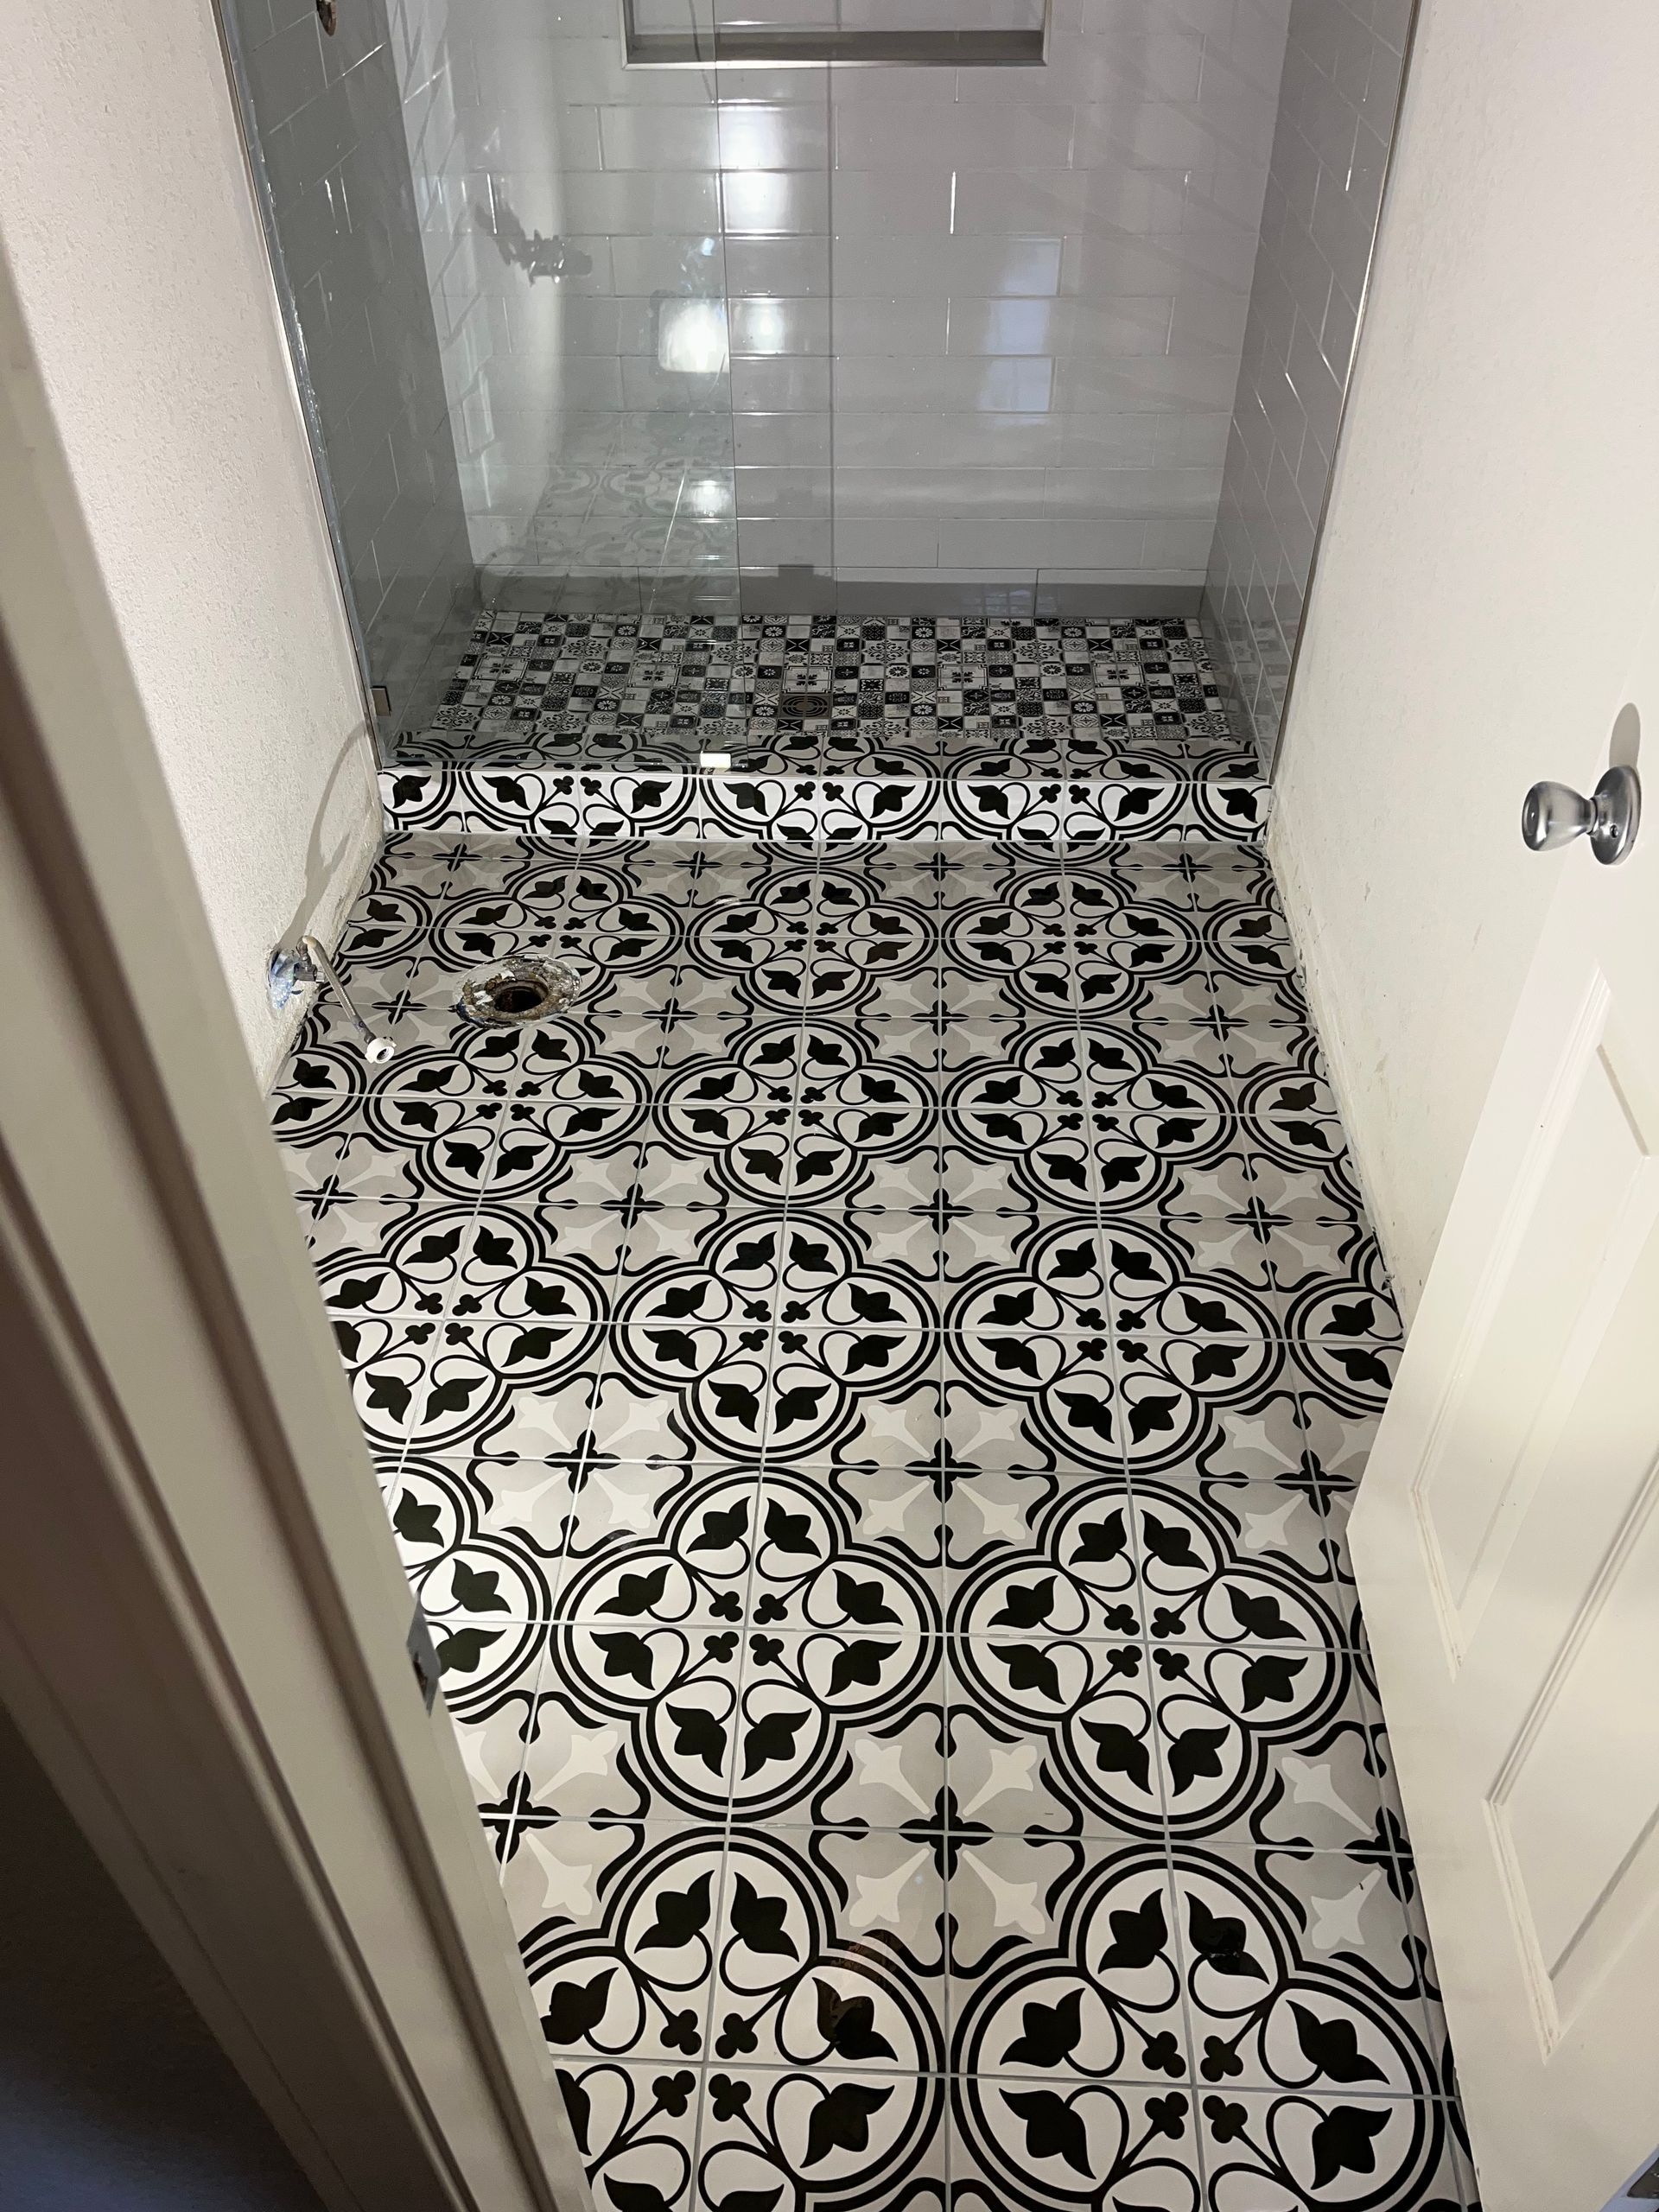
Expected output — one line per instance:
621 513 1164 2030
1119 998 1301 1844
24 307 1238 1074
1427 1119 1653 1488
228 0 478 728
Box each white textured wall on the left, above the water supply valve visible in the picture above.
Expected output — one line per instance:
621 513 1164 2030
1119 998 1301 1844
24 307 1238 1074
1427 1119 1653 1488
0 0 378 1079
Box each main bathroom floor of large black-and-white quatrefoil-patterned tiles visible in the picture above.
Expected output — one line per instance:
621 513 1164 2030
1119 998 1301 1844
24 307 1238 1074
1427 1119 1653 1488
274 834 1473 2212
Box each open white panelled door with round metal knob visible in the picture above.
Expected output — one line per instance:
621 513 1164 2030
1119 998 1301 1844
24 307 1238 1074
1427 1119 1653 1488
1351 600 1659 2212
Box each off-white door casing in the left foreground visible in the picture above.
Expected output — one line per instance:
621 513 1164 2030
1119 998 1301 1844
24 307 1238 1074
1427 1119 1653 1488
0 211 591 2212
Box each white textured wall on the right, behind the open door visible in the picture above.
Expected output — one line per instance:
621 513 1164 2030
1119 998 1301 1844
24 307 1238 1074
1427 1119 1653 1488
1272 0 1659 1305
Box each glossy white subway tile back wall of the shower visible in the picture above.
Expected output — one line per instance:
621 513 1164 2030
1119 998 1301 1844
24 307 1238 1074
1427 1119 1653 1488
387 0 1289 613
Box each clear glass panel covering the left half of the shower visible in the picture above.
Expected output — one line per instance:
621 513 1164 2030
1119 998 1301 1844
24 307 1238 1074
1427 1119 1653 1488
226 0 834 754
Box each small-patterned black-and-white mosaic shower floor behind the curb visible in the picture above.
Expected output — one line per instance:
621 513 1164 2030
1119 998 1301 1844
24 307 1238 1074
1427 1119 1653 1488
403 614 1239 781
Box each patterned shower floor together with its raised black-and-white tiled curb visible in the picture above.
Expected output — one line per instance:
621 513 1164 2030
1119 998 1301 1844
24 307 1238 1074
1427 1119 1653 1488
380 613 1268 842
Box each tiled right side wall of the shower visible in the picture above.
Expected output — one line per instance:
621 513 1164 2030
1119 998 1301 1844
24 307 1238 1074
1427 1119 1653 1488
1204 0 1411 761
